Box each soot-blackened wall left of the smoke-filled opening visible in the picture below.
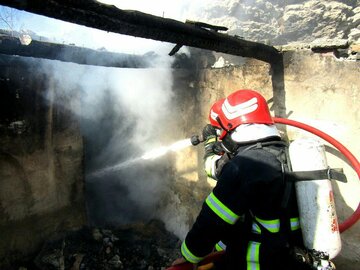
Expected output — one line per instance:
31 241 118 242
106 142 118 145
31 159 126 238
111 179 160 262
0 55 86 266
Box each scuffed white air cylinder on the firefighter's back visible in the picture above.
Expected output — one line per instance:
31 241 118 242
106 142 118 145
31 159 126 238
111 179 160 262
289 138 341 259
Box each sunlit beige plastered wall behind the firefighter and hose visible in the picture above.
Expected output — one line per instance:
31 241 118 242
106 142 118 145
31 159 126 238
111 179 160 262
175 50 360 270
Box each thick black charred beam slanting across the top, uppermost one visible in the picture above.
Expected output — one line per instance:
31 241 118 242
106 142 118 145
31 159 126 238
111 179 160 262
0 0 279 63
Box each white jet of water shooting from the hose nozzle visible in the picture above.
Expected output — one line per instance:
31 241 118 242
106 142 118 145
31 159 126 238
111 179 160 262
88 135 197 177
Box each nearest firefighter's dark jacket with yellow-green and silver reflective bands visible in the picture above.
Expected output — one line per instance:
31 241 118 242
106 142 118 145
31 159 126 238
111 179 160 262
181 140 302 270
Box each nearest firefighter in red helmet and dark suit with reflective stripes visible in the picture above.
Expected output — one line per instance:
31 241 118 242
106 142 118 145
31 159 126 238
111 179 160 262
173 89 307 270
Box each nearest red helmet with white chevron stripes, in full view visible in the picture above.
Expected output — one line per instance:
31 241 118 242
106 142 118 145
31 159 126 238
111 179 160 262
219 89 274 138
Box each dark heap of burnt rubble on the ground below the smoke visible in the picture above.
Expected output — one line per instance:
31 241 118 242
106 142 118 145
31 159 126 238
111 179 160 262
27 220 181 270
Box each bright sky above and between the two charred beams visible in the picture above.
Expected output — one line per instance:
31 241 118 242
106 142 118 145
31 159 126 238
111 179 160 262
3 0 205 54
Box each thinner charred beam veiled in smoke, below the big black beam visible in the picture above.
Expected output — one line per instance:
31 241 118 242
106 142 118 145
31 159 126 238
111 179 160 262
0 36 150 68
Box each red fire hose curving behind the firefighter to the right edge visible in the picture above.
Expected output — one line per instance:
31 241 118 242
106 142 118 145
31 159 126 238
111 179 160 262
273 117 360 232
